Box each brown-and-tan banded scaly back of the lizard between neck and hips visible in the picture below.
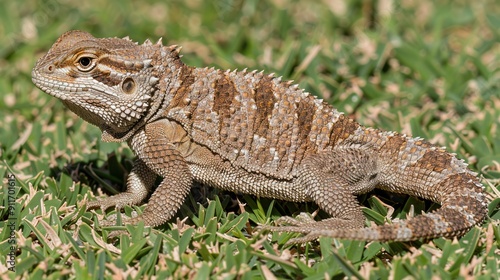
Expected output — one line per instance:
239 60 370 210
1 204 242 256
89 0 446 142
162 66 359 179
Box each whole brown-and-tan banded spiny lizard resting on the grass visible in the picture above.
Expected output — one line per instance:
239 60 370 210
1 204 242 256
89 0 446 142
32 30 487 243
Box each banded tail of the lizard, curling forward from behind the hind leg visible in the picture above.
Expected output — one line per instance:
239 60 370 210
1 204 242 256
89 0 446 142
348 137 487 241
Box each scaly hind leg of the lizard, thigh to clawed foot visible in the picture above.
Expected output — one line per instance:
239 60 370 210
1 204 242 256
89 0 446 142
265 148 378 243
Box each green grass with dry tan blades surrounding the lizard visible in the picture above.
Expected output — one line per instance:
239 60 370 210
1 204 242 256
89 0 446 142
0 0 500 279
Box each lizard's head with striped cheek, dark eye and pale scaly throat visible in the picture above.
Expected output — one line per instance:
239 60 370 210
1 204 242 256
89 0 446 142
32 31 182 140
